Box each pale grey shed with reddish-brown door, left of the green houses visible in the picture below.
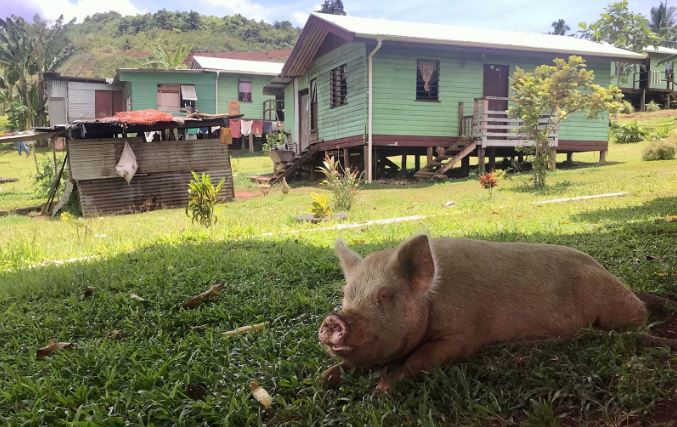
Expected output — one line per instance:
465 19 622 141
45 73 125 126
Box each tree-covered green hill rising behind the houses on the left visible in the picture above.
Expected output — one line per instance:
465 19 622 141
59 10 299 77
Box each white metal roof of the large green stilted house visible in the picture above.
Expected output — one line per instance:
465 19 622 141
311 12 645 59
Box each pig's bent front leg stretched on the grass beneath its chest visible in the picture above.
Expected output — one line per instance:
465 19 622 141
376 339 474 394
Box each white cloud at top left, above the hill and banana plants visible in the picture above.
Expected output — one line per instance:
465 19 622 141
30 0 142 22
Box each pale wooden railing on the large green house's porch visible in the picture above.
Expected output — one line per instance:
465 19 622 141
463 96 559 148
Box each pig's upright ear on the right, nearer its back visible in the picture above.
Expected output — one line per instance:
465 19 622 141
394 234 435 292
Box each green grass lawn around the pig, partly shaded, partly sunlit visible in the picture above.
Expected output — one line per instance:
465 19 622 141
0 120 677 426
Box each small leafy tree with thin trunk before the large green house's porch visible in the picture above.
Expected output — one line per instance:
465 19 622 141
510 56 622 188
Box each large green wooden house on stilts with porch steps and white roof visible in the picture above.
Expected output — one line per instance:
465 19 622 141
267 13 643 180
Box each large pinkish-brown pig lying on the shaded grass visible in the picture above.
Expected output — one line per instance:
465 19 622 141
319 235 647 393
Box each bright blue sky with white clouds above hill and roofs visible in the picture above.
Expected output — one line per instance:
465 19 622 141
0 0 656 32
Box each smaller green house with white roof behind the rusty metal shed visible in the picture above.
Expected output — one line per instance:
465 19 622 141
116 56 282 119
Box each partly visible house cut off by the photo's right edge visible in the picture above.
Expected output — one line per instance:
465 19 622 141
611 46 677 110
